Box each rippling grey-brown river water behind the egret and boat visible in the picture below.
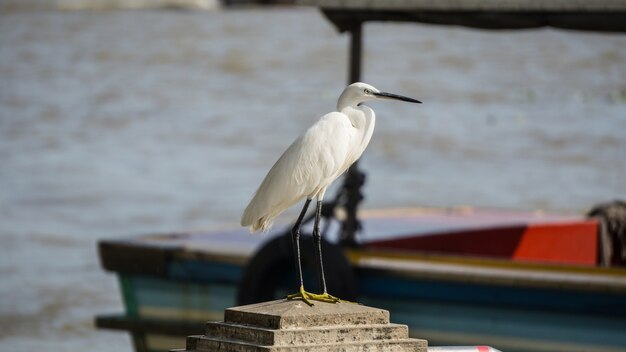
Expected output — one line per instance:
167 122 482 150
0 8 626 352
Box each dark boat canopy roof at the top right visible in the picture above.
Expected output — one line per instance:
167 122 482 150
298 0 626 32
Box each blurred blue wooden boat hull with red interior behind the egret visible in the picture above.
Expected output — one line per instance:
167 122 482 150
97 208 626 351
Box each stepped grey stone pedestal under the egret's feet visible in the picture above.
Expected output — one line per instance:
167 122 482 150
177 300 427 352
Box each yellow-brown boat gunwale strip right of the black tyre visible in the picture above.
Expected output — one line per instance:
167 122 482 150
346 249 626 294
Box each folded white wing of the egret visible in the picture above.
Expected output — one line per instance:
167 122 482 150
241 112 355 231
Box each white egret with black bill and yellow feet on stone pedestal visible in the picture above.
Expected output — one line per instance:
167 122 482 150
241 82 421 305
